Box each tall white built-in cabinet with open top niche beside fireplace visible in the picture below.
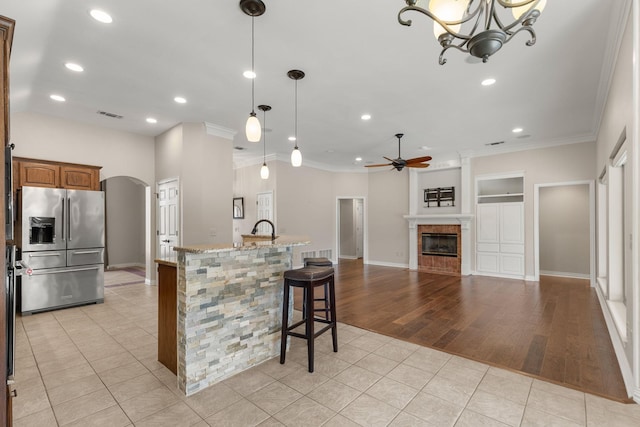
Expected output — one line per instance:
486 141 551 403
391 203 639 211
476 177 524 278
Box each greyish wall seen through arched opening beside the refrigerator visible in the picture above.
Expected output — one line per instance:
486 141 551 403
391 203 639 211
104 176 146 267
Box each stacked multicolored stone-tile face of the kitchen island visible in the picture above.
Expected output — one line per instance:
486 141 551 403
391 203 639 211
177 247 292 396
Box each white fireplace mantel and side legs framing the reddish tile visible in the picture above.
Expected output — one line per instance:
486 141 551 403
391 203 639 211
404 214 473 276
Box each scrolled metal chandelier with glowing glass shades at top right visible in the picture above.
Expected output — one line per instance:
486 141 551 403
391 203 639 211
398 0 547 65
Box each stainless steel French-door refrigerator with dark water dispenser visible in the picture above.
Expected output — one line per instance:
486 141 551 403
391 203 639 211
16 187 105 314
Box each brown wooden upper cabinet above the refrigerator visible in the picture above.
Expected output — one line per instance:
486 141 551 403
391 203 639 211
13 157 101 191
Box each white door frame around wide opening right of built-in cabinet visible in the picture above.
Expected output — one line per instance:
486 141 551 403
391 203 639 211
533 180 596 287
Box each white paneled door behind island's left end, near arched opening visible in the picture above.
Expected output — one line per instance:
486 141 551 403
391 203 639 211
157 179 180 258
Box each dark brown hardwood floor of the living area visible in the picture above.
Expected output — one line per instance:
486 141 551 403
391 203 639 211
298 260 629 402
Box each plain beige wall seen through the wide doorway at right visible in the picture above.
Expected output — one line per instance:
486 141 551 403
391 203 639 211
539 184 590 278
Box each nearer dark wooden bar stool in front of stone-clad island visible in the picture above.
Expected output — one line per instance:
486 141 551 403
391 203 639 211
280 266 338 372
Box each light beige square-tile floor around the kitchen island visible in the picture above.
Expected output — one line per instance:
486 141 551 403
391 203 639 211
13 271 640 427
